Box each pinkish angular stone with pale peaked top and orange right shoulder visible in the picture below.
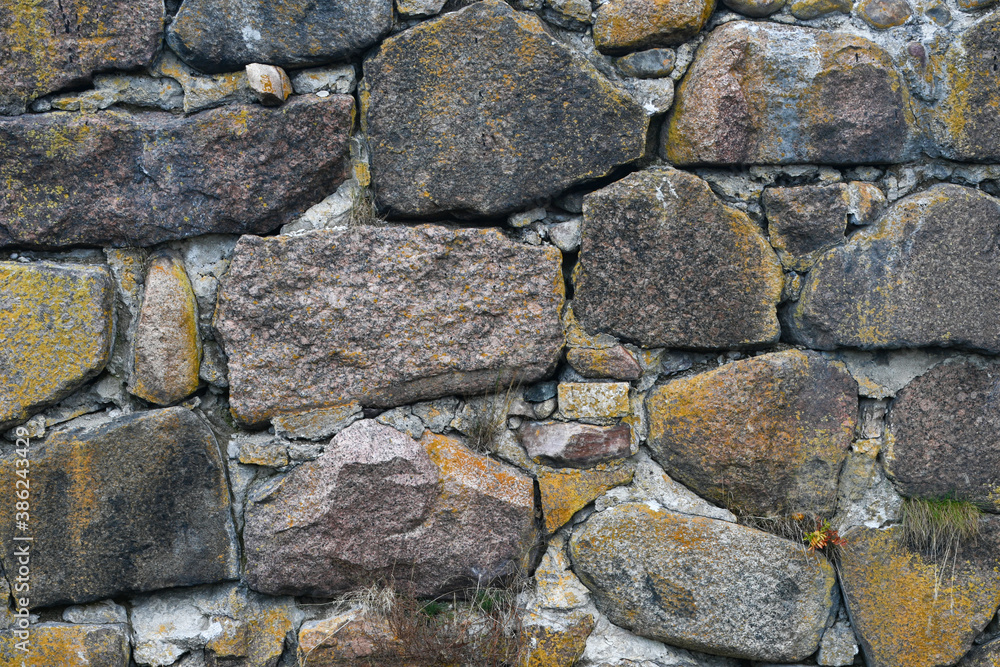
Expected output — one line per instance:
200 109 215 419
243 420 535 596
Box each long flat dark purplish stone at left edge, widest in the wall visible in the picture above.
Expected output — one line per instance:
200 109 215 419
0 96 354 247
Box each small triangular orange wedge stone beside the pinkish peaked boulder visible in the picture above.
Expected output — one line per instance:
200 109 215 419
538 465 633 533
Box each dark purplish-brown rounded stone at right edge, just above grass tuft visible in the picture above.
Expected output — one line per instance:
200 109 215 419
883 359 1000 512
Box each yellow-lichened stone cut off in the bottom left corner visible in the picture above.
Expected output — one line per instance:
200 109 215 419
0 623 129 667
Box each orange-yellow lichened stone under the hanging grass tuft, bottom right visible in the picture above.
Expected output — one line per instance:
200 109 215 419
840 518 1000 667
